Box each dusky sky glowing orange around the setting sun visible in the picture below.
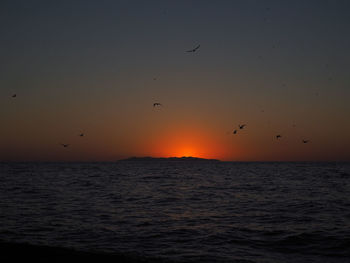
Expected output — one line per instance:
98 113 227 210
0 0 350 161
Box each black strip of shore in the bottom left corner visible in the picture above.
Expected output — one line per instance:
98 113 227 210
0 241 171 263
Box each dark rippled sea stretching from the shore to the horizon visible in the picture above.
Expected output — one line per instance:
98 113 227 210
0 161 350 263
